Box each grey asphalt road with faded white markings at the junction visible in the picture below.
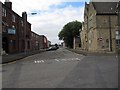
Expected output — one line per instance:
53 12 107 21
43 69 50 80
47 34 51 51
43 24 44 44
2 48 118 88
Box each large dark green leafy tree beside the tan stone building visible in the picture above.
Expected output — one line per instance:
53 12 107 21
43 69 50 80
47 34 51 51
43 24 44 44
58 20 82 48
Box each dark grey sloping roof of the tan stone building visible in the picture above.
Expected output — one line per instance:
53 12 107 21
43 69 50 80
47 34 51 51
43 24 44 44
92 2 118 14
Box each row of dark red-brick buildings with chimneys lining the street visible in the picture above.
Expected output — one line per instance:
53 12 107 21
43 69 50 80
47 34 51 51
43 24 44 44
0 0 47 54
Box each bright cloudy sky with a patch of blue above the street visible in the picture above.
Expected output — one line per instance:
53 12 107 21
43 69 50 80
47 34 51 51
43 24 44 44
1 0 119 44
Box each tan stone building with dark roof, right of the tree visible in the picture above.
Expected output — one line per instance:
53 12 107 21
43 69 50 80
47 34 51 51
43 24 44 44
80 2 118 52
